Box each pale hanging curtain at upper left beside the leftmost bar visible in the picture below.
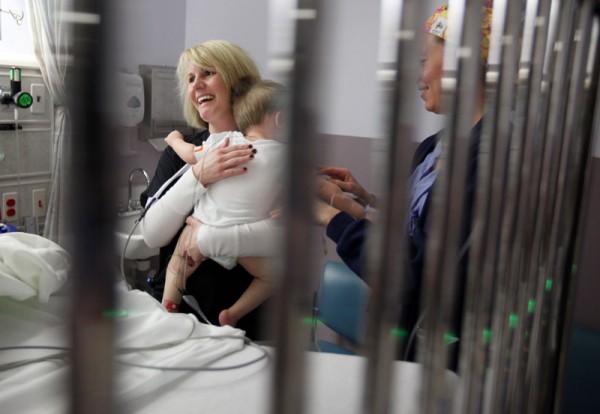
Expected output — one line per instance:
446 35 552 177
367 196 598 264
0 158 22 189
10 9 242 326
27 0 71 245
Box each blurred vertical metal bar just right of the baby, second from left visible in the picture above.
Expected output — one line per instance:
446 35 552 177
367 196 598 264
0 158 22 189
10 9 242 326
271 0 319 414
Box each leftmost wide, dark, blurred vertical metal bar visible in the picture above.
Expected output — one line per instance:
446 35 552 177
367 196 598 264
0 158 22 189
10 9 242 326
67 0 116 414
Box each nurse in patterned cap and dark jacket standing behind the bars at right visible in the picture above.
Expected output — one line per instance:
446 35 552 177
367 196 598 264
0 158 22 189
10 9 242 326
316 1 493 366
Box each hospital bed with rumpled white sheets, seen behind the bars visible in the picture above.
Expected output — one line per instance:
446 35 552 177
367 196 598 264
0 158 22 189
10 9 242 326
0 233 458 414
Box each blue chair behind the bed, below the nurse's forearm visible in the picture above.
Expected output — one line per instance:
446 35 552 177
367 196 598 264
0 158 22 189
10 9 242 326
311 261 370 355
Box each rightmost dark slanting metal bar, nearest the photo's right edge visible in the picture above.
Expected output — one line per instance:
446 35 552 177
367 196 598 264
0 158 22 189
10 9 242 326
530 2 594 410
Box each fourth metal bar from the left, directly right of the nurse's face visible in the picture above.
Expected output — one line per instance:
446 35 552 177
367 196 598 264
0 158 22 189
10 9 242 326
421 1 482 413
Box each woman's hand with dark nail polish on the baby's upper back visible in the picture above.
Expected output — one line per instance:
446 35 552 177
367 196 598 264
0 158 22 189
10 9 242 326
192 138 256 187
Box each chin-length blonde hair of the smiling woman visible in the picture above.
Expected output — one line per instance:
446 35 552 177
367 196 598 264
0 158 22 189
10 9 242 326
177 40 260 128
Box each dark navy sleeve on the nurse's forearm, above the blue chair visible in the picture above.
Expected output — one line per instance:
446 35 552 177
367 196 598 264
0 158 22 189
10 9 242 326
327 211 369 277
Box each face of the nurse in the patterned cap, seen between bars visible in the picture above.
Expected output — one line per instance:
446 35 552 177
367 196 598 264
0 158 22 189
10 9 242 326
419 33 444 114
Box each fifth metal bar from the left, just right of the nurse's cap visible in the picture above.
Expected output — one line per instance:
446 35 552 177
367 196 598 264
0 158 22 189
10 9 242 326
458 2 523 413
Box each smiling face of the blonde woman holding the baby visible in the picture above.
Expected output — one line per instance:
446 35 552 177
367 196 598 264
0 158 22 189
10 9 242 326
188 65 235 132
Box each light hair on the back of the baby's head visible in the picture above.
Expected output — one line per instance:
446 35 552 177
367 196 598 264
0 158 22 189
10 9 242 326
233 80 285 135
